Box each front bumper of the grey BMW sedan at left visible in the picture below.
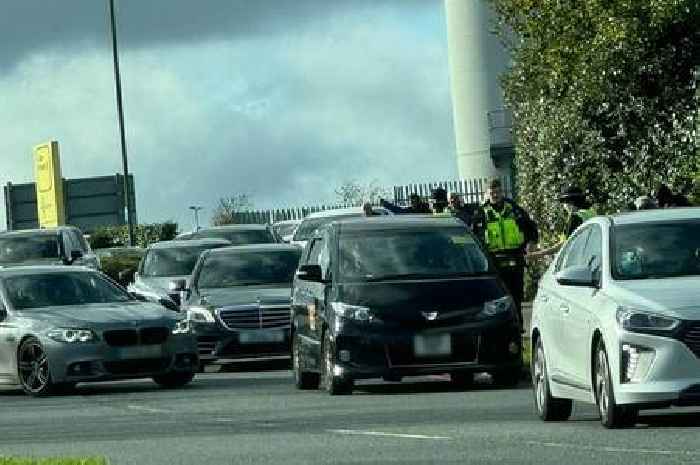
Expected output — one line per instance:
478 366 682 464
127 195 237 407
46 335 199 383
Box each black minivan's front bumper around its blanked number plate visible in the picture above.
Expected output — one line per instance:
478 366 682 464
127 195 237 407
333 320 522 379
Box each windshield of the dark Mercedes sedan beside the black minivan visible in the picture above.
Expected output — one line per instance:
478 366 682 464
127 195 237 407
196 250 301 289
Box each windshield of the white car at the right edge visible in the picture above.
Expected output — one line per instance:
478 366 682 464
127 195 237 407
612 221 700 280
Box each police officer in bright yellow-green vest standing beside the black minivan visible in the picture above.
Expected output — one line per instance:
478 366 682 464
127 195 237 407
474 179 539 323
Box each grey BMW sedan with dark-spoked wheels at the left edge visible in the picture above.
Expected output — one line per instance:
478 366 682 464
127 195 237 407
0 266 199 396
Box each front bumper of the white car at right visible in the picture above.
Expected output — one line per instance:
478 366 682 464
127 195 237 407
615 332 700 407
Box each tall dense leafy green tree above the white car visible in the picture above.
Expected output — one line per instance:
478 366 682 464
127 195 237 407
490 0 700 239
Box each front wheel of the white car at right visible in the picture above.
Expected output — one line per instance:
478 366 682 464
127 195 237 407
593 341 639 428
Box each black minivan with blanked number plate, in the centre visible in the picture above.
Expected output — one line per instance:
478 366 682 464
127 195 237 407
292 216 522 394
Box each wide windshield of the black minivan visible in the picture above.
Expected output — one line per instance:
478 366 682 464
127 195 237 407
340 227 491 281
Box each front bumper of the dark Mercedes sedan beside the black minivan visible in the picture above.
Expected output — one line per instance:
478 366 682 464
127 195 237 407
195 324 291 363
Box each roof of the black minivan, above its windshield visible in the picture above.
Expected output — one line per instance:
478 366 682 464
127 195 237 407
329 215 467 234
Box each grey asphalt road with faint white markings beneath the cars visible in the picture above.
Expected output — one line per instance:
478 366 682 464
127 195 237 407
0 364 700 465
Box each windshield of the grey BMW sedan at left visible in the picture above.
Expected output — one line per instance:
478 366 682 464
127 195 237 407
3 272 131 310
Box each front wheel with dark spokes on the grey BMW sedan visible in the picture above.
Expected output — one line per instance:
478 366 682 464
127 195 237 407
17 337 56 397
